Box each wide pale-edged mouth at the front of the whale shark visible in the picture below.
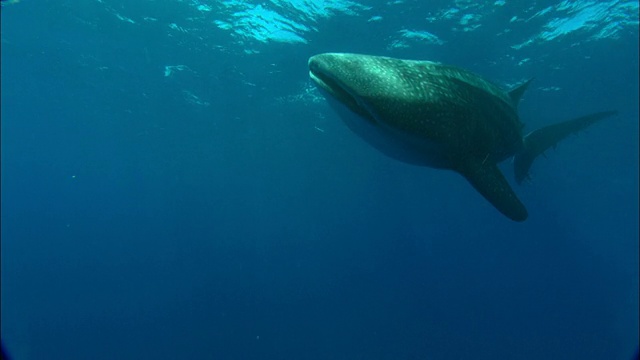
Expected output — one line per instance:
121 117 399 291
309 57 376 124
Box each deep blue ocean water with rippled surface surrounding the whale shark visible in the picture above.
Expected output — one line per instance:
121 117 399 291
1 0 639 359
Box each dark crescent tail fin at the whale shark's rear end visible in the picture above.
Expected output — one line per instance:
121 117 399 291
513 111 618 184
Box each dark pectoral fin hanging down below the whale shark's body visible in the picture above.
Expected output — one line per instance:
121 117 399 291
455 159 528 221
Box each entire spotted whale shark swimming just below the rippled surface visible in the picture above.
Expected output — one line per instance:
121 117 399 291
308 53 617 221
